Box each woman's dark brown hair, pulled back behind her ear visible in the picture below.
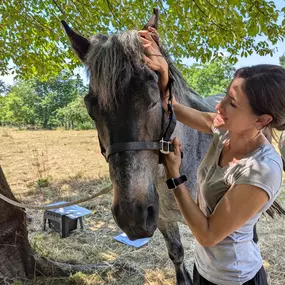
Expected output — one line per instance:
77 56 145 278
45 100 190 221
234 64 285 140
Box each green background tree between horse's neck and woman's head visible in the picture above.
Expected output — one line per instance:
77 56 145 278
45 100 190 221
183 58 235 97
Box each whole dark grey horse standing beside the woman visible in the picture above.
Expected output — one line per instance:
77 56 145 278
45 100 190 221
62 10 282 285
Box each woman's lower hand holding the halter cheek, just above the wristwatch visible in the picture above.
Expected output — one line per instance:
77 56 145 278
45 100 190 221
162 138 181 178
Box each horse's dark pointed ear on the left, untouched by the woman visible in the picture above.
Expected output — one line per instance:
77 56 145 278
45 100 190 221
61 21 90 62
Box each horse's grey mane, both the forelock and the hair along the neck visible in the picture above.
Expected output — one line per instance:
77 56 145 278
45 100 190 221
86 30 212 111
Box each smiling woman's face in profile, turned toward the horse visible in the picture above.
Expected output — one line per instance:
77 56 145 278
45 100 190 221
214 78 258 133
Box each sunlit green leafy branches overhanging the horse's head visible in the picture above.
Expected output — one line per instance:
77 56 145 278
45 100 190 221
0 0 285 78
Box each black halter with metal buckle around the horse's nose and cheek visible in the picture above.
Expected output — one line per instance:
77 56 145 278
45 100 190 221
98 80 176 163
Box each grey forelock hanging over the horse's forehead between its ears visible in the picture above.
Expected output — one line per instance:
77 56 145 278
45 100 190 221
86 31 145 109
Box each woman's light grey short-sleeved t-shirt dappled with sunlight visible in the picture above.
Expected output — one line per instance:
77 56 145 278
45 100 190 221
195 128 282 285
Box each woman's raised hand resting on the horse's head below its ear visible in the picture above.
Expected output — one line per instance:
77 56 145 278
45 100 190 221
138 27 169 93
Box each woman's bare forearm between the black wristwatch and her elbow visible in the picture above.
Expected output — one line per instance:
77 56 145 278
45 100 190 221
173 184 213 246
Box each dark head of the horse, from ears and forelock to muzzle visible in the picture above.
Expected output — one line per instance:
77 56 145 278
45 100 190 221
63 10 170 239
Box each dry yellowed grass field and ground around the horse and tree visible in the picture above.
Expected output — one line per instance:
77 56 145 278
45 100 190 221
0 128 285 285
